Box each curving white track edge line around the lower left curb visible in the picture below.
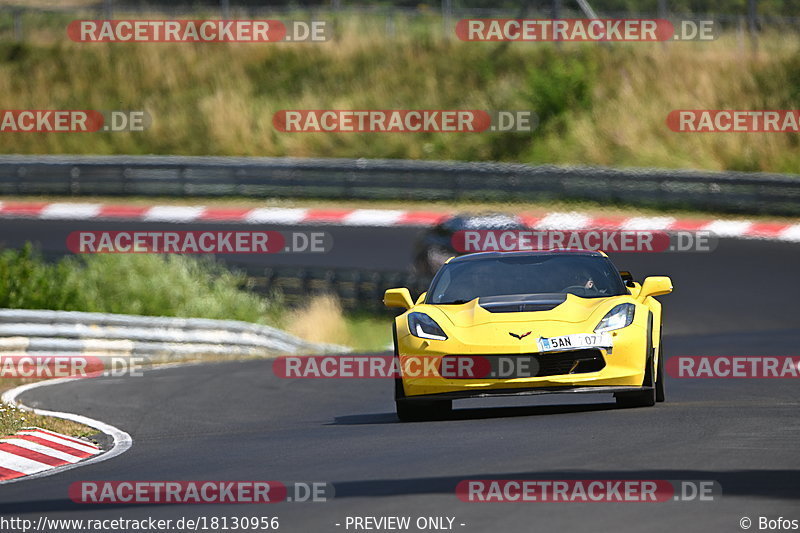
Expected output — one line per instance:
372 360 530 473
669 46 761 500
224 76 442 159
0 378 133 484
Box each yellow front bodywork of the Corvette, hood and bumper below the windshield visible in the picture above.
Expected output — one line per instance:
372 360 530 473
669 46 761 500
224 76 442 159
397 295 648 398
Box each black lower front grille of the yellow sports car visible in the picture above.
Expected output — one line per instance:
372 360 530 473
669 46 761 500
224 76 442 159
440 348 606 379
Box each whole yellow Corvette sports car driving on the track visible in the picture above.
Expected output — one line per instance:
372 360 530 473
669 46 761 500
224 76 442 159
384 250 672 421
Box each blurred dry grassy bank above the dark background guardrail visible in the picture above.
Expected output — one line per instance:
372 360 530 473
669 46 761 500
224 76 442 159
0 22 800 172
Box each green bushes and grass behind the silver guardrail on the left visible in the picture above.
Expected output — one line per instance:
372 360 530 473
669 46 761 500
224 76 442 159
0 245 283 324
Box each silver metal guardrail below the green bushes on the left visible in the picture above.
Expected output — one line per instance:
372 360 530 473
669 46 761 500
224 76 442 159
0 309 347 362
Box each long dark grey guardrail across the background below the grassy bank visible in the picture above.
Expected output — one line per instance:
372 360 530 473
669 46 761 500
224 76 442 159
0 155 800 216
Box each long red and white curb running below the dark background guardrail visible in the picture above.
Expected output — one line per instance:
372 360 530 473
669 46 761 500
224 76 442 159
0 202 800 242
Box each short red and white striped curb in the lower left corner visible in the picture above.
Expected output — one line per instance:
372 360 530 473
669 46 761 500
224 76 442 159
0 428 101 481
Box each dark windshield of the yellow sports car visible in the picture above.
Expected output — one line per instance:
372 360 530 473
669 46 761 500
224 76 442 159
427 254 627 304
